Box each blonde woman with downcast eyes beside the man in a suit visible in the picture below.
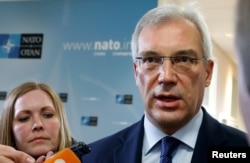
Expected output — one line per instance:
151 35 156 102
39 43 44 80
0 82 73 163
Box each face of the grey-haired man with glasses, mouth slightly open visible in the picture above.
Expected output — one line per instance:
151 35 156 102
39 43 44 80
134 20 213 134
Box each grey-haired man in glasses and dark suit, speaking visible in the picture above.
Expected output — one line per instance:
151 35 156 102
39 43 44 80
83 1 248 163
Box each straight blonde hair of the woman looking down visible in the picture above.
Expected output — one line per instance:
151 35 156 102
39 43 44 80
0 82 72 151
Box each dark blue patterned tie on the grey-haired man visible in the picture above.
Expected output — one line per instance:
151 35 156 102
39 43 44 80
160 136 180 163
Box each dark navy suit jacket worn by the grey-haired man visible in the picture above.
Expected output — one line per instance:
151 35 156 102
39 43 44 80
82 109 248 163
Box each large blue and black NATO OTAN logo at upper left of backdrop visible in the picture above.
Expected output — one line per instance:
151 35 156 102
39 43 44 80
0 33 43 59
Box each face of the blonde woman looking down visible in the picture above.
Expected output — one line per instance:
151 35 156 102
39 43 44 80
12 90 60 157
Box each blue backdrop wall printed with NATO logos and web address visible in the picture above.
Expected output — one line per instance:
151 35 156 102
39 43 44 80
0 0 157 143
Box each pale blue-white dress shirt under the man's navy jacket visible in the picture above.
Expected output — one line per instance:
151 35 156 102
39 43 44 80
142 109 203 163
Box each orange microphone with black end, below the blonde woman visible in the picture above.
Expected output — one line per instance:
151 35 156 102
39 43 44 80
44 142 91 163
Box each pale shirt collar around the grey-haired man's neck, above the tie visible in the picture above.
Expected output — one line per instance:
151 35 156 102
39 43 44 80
143 109 203 154
